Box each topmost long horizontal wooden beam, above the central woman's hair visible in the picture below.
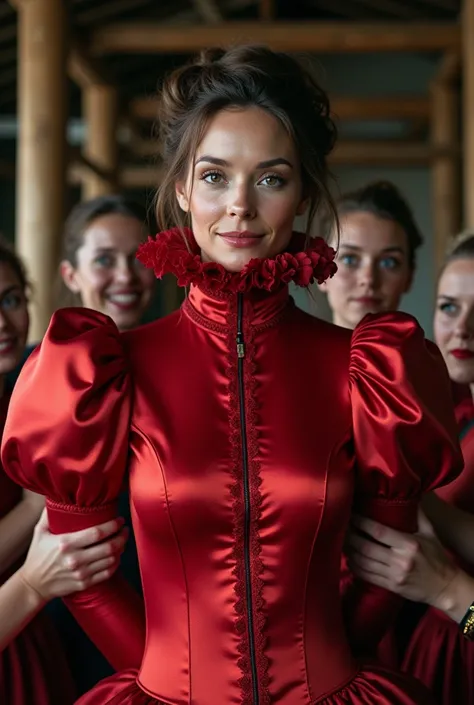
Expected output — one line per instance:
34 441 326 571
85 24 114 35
89 22 461 54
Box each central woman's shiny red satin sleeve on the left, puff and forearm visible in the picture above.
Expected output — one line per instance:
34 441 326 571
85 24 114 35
2 309 144 669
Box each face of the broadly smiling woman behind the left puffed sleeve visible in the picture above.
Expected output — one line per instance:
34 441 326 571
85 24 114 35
61 213 155 330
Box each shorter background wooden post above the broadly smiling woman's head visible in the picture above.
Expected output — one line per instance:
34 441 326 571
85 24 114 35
82 84 118 199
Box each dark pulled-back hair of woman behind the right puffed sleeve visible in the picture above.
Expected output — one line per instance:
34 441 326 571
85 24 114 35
336 181 423 269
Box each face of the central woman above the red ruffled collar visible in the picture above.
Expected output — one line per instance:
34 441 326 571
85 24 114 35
176 108 306 272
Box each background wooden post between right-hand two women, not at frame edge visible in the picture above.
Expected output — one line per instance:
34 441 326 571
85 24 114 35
431 66 461 272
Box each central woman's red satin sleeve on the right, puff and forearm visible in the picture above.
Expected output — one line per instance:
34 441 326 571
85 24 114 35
343 313 463 654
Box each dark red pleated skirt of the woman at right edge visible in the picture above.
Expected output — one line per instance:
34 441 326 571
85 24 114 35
402 609 474 705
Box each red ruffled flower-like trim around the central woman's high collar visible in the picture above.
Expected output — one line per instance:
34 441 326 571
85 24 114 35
137 228 337 293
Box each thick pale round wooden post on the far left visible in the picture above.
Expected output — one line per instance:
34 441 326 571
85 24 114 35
16 0 66 341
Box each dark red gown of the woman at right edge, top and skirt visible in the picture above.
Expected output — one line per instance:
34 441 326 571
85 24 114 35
401 398 474 705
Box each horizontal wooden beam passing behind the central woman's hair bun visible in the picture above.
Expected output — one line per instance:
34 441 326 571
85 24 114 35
129 96 430 122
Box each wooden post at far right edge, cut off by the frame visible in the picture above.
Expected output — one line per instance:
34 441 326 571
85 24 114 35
462 0 474 228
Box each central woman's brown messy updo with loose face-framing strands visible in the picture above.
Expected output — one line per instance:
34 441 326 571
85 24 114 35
156 46 337 239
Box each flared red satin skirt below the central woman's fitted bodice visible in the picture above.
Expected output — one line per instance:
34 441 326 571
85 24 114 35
77 664 436 705
